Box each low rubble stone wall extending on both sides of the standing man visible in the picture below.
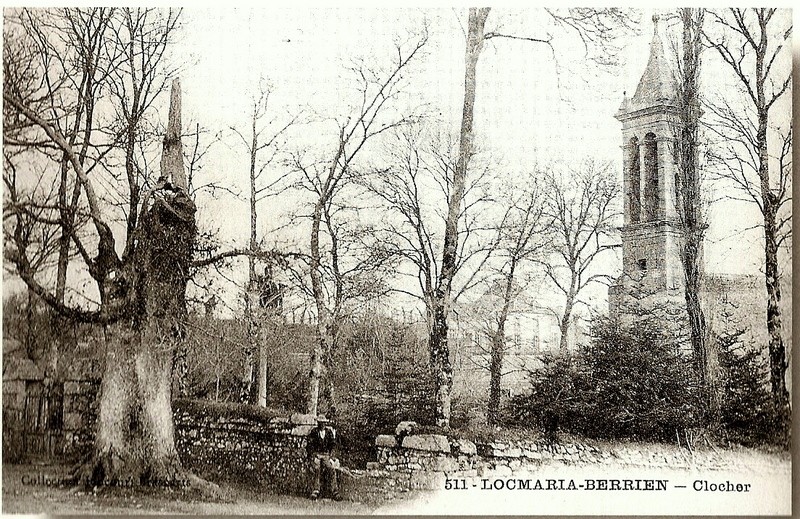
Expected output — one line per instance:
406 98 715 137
43 398 727 500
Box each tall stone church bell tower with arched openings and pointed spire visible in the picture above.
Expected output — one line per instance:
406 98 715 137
609 16 683 315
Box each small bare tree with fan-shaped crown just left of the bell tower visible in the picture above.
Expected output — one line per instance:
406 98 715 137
544 161 619 352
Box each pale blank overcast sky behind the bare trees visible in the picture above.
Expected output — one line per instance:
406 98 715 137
1 3 788 318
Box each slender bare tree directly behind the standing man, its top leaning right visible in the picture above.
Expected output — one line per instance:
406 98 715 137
292 32 428 414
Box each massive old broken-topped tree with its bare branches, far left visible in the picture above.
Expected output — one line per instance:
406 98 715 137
3 8 222 494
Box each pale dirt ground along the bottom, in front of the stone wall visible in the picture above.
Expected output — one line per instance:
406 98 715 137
2 446 792 516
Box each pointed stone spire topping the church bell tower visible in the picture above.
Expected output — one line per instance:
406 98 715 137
620 15 677 112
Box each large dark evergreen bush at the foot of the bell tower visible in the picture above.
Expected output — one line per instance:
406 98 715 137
508 318 699 440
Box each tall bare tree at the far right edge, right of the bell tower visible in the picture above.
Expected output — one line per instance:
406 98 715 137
703 8 792 407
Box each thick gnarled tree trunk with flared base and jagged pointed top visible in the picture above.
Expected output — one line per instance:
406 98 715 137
77 80 198 486
